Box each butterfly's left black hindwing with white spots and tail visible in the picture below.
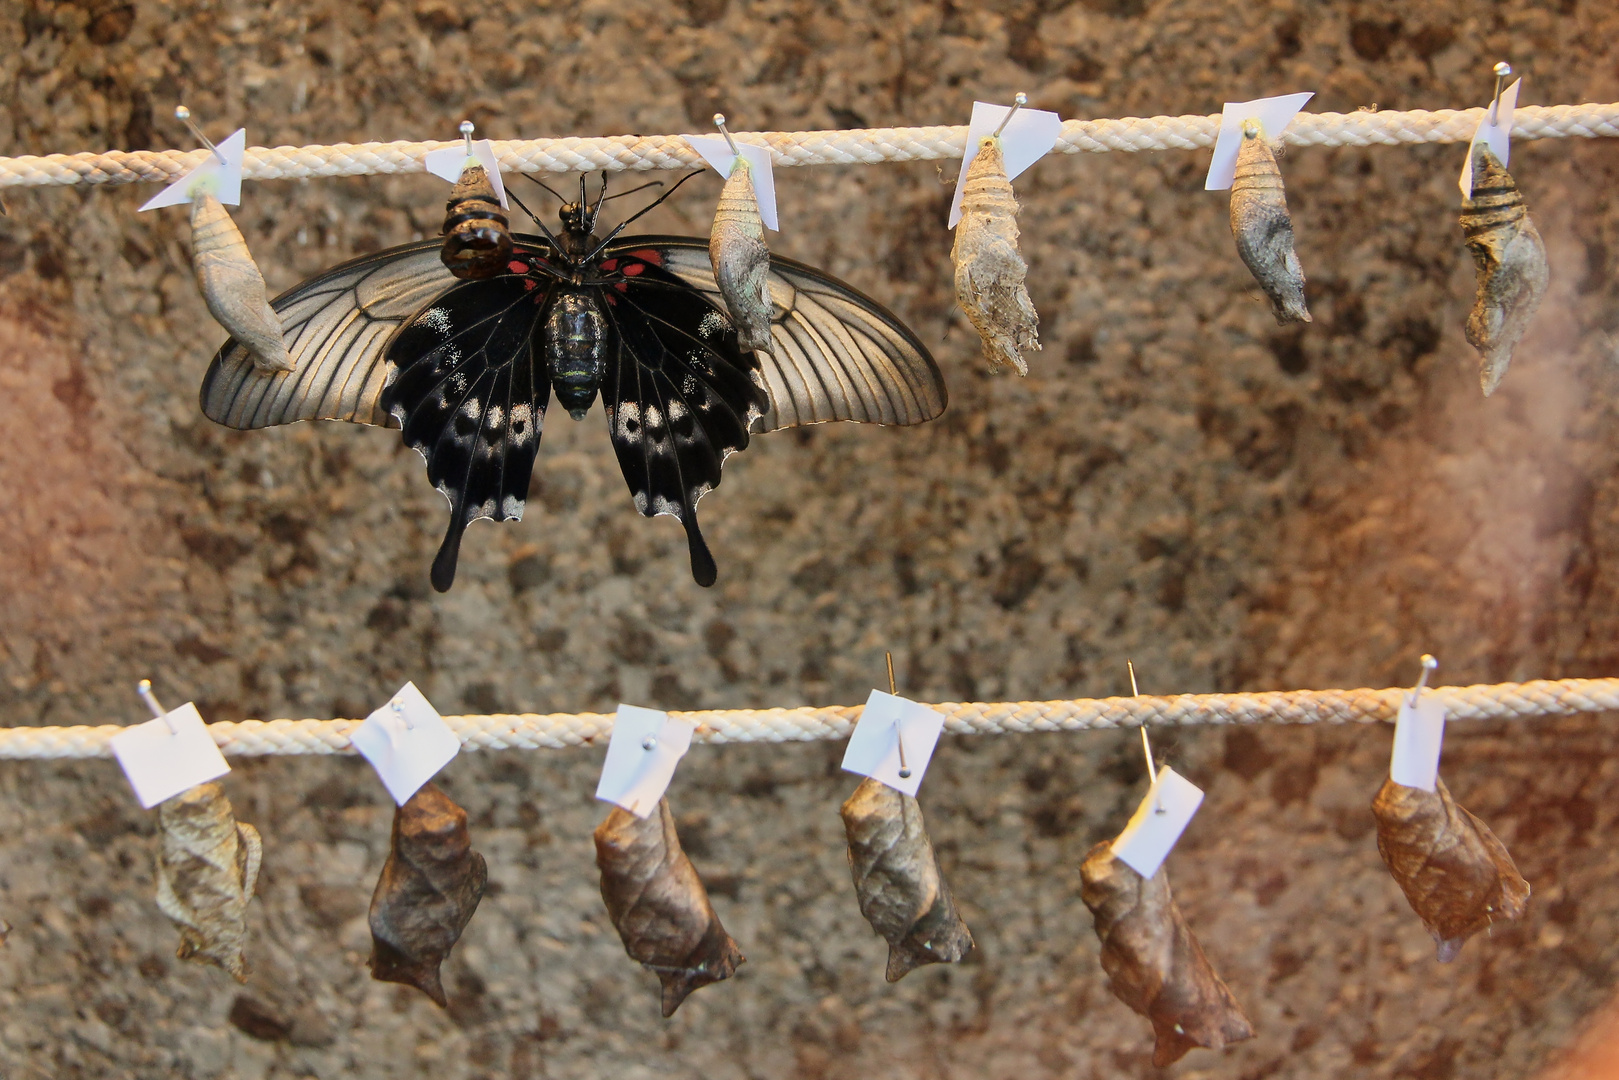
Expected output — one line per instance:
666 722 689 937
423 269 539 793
379 251 555 593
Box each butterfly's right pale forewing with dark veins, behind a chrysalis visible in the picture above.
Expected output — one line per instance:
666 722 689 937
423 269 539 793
609 236 949 431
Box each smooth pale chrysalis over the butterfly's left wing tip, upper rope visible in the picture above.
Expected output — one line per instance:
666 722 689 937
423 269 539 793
191 191 293 371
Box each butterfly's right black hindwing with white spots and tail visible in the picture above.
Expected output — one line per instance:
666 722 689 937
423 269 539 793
599 246 769 585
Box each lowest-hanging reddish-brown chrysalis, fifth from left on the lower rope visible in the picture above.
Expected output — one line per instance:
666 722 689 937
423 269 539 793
1080 842 1253 1069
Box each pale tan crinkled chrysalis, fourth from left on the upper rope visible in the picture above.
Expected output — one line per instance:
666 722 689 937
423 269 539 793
950 136 1039 376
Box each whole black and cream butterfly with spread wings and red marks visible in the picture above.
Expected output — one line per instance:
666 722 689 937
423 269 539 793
201 173 945 593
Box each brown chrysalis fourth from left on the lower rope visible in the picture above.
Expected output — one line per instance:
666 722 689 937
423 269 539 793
842 777 973 983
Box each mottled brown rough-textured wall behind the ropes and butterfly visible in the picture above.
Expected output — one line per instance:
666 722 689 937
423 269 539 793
0 0 1619 1080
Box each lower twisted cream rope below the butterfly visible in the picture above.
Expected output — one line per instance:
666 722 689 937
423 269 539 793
0 678 1619 759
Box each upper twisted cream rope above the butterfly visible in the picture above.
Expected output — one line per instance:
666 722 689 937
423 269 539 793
0 102 1619 188
